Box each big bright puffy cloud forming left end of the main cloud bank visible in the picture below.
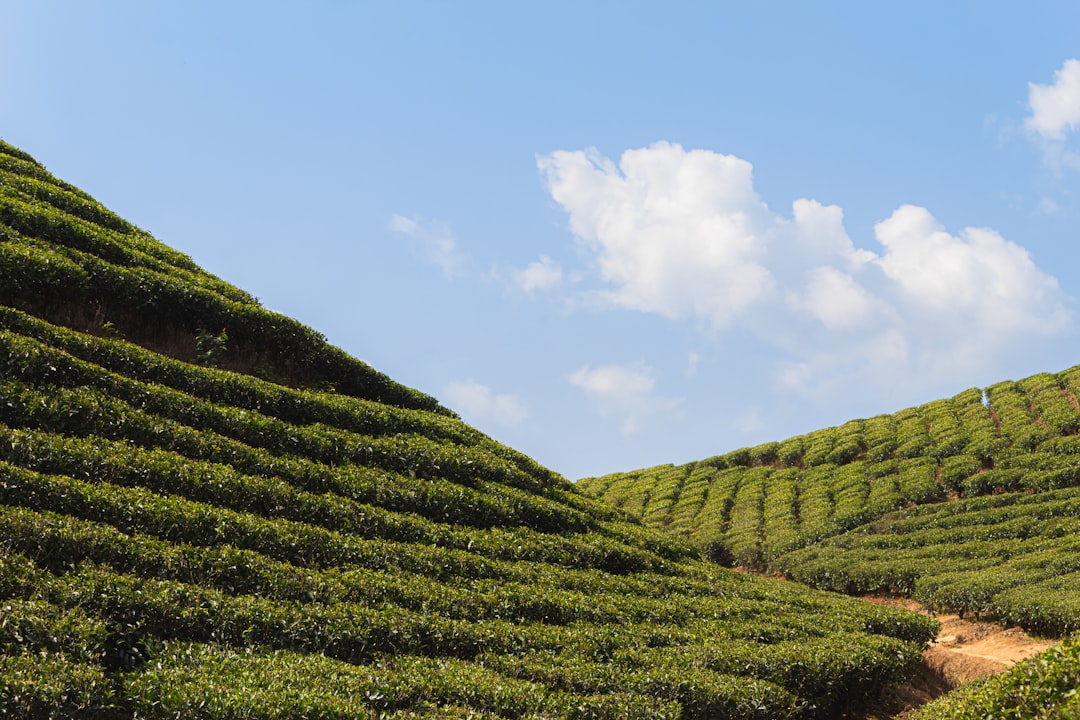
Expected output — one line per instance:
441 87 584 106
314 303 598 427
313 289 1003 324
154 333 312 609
538 142 773 326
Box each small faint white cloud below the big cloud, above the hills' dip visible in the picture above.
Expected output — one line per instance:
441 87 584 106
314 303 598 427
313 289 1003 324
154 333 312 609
569 364 679 435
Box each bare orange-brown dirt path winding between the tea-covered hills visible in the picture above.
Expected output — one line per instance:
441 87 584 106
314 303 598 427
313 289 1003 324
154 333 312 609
863 597 1056 720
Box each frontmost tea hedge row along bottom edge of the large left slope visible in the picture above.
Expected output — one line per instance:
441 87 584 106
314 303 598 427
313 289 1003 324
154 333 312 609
125 643 679 720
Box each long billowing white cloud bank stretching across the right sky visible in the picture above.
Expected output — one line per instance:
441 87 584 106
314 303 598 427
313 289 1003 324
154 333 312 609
538 141 1070 399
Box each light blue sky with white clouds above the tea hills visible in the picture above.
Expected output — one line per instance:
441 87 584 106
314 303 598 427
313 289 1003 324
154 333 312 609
6 0 1080 478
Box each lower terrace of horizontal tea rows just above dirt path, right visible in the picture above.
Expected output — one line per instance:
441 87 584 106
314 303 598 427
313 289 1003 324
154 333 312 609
778 487 1080 636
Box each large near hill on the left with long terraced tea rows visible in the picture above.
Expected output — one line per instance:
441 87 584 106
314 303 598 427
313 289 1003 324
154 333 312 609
0 144 936 719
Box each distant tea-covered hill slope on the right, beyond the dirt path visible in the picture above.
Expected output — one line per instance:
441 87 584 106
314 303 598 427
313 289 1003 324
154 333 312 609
579 367 1080 635
